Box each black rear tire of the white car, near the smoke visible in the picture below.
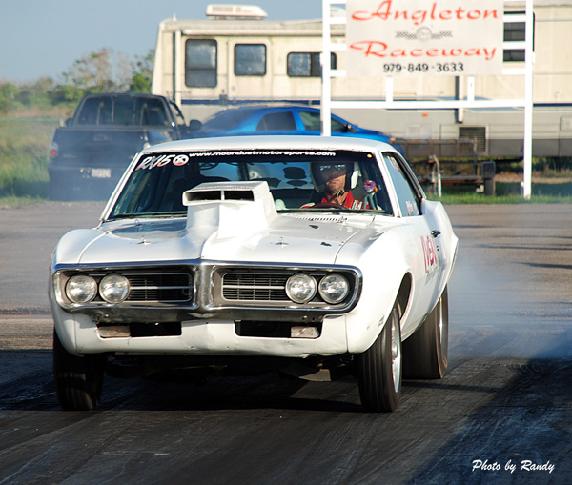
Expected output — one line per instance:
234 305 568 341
403 287 449 379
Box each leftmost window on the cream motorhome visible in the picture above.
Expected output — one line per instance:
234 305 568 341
185 39 216 88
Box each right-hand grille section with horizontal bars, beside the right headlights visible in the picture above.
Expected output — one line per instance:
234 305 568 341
222 271 293 301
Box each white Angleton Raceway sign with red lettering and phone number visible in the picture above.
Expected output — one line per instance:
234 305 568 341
346 0 503 76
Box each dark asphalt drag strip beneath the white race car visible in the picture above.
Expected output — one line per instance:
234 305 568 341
0 205 572 484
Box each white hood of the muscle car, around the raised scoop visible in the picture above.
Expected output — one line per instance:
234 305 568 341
54 212 393 265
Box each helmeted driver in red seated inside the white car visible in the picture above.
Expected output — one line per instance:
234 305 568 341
303 163 368 210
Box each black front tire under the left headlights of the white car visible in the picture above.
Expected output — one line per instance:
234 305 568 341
53 331 105 411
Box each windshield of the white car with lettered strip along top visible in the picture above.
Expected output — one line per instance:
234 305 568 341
110 150 392 219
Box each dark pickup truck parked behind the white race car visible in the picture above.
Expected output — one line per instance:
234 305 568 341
49 93 188 200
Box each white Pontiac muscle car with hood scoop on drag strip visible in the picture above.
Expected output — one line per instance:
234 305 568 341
50 136 458 411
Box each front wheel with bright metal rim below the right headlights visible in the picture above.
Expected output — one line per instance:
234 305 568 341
357 305 401 412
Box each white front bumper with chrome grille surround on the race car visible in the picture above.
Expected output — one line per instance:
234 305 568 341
50 261 361 357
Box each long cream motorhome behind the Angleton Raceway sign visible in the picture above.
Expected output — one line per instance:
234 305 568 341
153 0 572 158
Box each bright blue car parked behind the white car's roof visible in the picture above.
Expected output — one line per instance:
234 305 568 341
190 106 392 143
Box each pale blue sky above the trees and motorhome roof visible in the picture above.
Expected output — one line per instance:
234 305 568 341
0 0 321 82
